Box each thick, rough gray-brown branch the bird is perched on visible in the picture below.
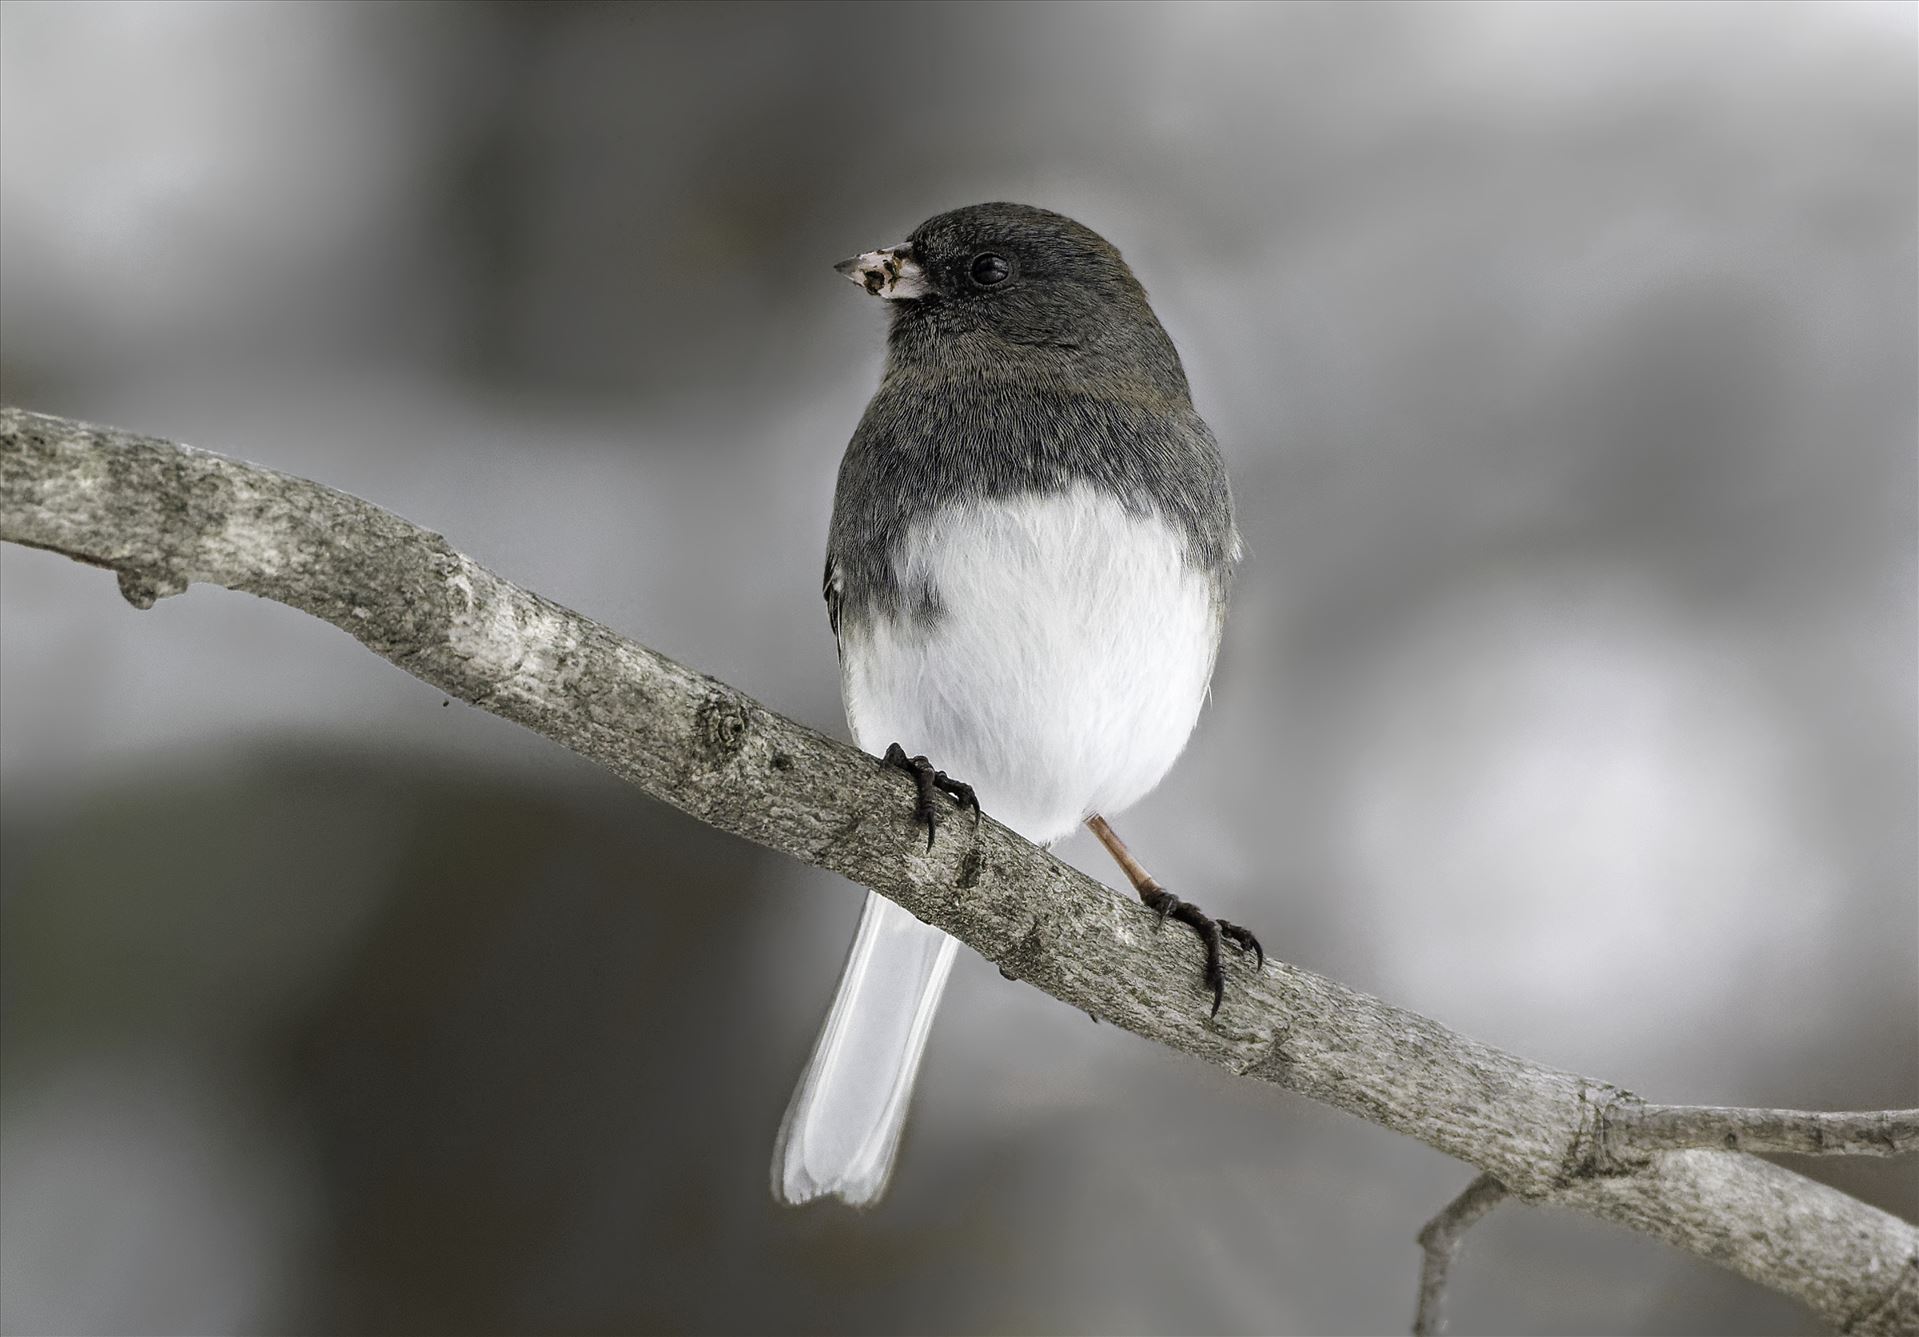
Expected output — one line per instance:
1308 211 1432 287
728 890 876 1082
0 409 1919 1333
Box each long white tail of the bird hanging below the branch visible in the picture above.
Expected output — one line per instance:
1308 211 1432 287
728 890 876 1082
773 894 960 1207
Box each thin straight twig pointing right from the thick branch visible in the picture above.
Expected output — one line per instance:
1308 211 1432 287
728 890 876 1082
1606 1105 1919 1157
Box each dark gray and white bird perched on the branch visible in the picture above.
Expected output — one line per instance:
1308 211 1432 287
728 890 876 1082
773 203 1265 1205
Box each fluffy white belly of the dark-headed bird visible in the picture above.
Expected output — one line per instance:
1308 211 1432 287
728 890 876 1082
841 485 1220 842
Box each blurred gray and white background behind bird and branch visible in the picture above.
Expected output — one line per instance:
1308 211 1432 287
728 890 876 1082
0 0 1919 1335
